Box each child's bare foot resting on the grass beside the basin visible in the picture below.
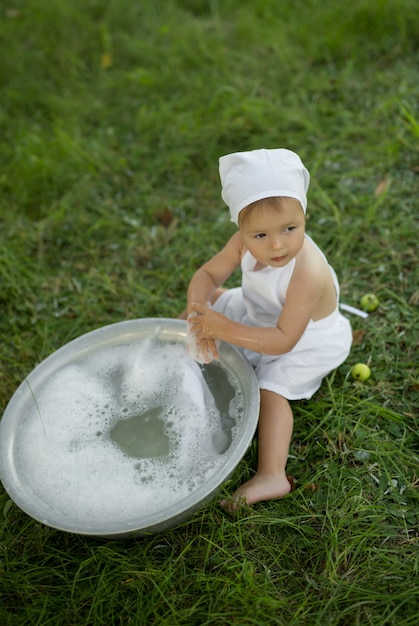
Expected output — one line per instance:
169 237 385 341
220 474 291 512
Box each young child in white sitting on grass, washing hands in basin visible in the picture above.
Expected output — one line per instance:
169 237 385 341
184 148 352 508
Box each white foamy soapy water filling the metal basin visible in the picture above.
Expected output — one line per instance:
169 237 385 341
16 339 243 525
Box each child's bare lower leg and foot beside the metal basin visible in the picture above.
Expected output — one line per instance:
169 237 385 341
222 389 294 509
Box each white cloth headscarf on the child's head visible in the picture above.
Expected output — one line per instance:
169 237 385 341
220 148 310 224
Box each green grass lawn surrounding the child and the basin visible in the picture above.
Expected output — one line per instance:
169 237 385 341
0 0 419 626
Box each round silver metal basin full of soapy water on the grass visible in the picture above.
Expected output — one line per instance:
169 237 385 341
0 318 259 539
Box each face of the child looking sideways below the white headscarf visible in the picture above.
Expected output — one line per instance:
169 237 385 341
240 198 305 267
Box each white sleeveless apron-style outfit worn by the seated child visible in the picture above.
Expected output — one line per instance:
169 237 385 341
213 235 352 400
